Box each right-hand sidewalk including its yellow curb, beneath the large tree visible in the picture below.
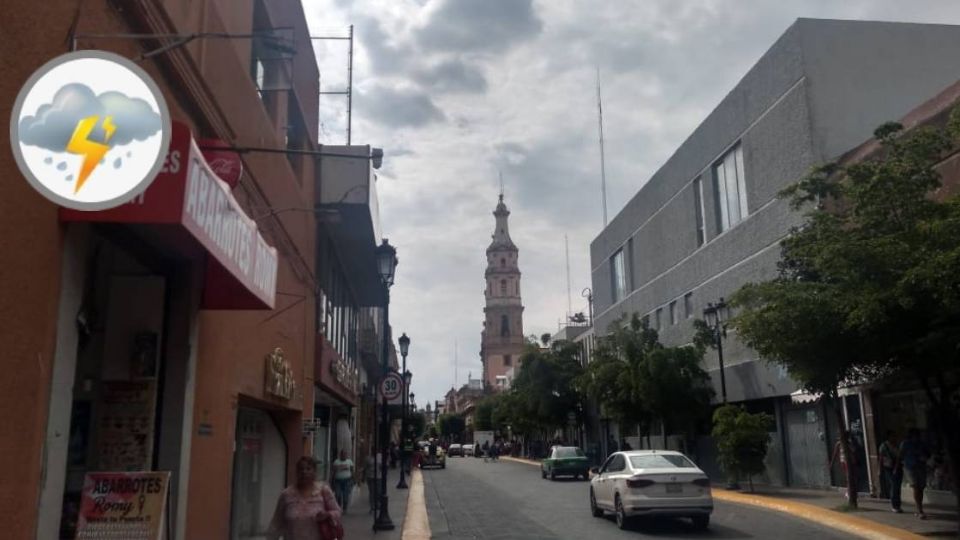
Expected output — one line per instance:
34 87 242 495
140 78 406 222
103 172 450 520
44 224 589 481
713 486 958 538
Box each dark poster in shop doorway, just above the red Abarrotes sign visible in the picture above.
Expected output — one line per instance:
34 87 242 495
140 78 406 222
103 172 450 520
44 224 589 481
97 380 156 471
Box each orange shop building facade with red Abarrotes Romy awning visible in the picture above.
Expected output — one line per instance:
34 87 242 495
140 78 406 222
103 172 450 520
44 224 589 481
0 0 319 539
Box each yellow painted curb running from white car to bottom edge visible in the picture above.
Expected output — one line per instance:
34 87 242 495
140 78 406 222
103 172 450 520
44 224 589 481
713 489 925 540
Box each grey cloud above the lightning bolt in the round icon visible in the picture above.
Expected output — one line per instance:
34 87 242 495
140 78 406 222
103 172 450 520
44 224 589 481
19 83 162 152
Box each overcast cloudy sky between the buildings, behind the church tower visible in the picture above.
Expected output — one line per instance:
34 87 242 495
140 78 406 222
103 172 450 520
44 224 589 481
303 0 960 410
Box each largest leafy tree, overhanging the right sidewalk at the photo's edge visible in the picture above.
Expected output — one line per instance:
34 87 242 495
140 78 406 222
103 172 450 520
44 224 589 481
732 111 960 506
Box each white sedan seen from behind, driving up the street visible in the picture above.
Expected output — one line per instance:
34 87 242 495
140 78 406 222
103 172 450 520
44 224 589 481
590 450 713 529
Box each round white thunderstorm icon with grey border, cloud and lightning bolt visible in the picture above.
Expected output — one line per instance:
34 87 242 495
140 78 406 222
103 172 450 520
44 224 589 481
10 51 170 210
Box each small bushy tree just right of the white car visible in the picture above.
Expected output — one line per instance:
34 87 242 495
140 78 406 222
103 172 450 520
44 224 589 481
713 405 774 492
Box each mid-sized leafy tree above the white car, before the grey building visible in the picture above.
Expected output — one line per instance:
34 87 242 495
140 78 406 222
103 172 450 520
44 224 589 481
577 314 713 442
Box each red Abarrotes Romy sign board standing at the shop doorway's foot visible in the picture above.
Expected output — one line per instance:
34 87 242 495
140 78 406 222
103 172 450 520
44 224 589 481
75 472 170 540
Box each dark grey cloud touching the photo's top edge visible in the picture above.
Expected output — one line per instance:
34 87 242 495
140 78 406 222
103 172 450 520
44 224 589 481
418 0 543 52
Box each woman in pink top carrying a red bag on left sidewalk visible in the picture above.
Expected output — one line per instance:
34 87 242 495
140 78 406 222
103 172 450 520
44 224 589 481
267 456 341 540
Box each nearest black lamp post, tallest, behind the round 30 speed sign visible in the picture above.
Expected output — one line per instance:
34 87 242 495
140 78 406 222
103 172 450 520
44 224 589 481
373 238 399 531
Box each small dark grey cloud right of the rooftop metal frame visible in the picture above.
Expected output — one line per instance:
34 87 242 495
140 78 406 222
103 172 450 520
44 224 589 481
356 85 445 128
